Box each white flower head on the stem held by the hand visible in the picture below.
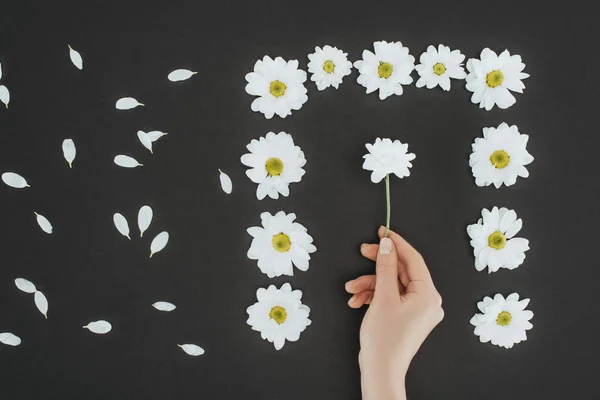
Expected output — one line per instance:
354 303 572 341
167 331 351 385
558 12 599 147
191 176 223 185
363 138 416 183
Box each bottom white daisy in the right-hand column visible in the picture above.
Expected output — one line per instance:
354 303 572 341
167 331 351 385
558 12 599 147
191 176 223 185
471 293 533 349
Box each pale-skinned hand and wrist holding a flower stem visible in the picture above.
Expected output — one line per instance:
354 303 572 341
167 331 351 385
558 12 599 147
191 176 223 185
346 227 444 400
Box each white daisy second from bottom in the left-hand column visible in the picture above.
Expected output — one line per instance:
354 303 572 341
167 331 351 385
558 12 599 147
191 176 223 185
247 211 317 278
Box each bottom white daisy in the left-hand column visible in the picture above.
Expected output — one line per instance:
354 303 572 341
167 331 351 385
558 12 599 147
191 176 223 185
246 283 311 350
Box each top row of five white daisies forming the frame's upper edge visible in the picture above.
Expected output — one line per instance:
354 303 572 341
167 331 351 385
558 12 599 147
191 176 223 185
241 41 529 119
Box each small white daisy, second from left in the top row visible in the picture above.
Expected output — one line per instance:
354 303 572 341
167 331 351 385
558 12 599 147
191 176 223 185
308 46 352 90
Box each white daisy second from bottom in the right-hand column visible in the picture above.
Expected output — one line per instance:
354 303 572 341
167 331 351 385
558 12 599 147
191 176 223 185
467 207 529 273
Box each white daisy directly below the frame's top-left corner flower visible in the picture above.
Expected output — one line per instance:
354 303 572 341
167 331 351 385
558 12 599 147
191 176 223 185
241 132 306 200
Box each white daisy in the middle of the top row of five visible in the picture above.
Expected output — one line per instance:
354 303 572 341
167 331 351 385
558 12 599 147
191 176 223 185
354 41 415 100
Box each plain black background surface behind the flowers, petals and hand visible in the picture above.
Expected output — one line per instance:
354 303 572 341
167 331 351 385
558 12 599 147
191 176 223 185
0 0 600 400
